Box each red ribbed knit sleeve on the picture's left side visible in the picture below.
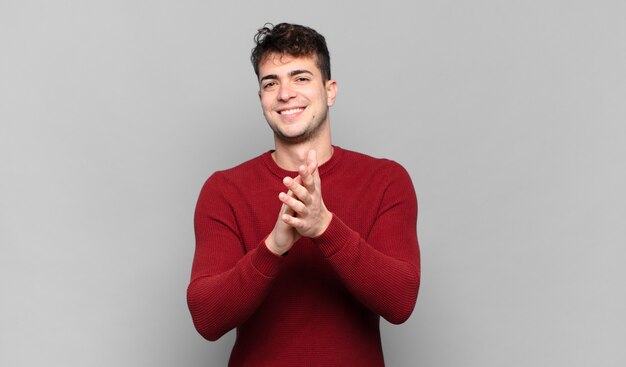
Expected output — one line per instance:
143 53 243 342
187 173 284 340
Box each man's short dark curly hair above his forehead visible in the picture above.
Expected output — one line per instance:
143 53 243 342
250 23 330 81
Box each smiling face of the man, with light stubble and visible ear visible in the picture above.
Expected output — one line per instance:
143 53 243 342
259 54 337 144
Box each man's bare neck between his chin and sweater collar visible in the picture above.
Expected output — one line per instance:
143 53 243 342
272 139 333 171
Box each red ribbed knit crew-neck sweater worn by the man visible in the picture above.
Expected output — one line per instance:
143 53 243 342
187 147 420 366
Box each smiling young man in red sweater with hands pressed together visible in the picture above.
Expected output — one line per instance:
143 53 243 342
187 23 420 366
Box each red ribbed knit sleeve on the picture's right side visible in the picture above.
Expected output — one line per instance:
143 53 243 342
313 163 420 324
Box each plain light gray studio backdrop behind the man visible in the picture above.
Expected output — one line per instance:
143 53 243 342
0 0 626 367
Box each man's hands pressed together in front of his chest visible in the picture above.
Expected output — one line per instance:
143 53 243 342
265 150 332 255
